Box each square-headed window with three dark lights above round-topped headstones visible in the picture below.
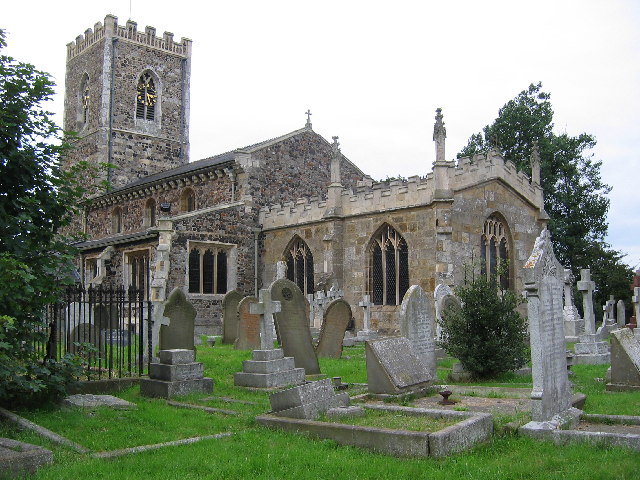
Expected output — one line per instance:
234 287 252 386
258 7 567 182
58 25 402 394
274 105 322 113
189 244 228 294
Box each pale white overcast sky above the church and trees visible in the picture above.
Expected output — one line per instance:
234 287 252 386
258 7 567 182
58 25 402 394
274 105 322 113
5 0 640 268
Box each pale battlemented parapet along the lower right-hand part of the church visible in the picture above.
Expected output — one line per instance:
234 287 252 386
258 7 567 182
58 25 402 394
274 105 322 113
260 152 543 230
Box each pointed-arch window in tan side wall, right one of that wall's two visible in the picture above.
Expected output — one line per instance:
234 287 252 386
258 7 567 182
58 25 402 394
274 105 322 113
369 225 409 305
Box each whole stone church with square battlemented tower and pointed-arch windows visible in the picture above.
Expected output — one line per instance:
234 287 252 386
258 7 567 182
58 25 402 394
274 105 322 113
64 15 547 334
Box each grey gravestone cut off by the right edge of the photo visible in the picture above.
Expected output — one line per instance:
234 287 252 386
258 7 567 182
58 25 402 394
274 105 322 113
607 328 640 391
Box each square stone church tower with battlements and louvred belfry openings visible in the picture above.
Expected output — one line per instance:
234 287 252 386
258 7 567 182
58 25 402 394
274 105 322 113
64 15 191 188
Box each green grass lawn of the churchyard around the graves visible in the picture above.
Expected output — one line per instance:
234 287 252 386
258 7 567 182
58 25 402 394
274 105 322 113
0 345 640 480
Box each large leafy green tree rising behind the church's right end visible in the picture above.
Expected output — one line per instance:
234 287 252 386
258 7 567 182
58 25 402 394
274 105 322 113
458 83 633 303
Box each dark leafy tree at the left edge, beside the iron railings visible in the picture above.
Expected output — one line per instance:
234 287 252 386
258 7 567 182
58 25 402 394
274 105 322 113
0 30 87 404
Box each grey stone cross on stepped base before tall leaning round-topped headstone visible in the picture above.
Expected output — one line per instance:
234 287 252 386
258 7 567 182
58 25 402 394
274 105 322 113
233 288 304 388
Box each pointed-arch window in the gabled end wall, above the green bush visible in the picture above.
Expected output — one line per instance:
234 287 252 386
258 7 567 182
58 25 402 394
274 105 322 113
480 214 510 290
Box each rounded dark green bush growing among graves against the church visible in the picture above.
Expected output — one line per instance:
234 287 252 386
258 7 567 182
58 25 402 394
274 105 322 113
438 276 529 378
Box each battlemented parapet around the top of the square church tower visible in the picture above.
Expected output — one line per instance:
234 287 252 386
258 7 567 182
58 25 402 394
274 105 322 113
67 15 191 60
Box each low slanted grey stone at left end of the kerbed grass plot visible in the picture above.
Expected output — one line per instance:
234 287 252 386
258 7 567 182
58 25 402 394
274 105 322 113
269 378 349 420
